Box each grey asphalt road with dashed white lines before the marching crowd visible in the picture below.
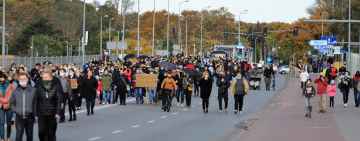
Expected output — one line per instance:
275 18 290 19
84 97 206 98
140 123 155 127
21 77 286 141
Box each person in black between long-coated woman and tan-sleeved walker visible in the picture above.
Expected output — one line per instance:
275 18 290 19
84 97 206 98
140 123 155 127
216 73 230 112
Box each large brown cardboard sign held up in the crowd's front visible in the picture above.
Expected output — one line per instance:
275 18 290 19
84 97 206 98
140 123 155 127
135 74 157 88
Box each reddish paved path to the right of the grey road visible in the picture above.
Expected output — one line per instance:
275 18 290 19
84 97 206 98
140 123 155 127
228 80 345 141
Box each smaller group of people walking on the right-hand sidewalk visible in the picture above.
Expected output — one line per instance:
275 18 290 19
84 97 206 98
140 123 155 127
300 63 360 118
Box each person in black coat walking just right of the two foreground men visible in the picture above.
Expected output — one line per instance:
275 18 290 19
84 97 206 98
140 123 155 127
80 69 98 116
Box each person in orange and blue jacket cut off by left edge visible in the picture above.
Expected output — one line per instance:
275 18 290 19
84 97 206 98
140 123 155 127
0 72 15 141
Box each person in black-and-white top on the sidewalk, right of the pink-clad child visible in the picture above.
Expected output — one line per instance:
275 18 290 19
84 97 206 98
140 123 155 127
338 70 352 108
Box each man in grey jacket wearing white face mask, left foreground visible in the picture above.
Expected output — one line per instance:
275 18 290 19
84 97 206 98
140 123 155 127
10 72 36 141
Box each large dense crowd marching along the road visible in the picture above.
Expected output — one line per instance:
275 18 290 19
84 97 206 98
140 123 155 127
0 56 275 141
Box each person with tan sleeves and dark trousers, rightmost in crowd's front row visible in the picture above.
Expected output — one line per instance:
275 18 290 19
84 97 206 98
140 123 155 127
231 73 249 114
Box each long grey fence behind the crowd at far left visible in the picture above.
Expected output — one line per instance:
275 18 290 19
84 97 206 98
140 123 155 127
0 55 100 68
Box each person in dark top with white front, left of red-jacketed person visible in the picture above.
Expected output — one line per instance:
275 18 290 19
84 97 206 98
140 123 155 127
303 79 316 118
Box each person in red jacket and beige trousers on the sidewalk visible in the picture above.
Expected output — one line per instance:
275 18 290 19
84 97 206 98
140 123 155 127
315 75 328 113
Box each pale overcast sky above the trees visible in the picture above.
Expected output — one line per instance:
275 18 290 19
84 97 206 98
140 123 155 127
92 0 315 23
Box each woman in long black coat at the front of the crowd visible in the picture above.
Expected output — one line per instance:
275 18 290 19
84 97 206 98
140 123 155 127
200 71 213 113
